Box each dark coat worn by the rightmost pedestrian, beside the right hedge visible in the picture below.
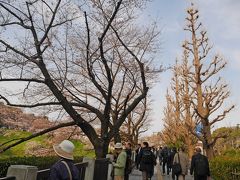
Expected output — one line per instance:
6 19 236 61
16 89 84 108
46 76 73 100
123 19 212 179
190 153 210 180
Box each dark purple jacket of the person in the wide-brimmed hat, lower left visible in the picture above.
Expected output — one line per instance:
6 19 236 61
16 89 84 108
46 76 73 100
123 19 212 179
49 159 80 180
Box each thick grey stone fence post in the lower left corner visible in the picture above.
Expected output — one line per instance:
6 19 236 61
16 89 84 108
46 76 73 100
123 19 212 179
7 165 38 180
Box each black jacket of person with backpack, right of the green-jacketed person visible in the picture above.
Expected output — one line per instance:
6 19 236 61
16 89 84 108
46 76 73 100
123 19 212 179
139 147 156 177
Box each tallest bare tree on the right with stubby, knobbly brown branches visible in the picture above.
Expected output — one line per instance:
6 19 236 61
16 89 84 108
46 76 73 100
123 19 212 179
183 7 234 158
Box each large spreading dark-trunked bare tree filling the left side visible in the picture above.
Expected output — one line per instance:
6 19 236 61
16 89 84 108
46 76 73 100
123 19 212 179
0 0 159 158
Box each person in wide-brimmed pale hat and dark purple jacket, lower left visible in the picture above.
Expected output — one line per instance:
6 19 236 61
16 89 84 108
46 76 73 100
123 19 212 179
49 140 80 180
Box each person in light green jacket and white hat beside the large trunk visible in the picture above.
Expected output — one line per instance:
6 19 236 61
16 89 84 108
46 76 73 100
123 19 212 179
113 143 127 180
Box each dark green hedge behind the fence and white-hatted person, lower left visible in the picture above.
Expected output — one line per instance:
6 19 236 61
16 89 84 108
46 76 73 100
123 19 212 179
0 156 82 177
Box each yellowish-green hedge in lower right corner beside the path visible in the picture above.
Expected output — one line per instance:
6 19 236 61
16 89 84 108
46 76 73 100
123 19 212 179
210 156 240 180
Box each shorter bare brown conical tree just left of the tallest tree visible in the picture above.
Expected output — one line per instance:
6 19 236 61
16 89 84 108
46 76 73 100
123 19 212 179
161 60 194 153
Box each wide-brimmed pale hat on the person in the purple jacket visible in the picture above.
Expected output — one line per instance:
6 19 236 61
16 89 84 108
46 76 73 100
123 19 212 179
53 140 75 160
